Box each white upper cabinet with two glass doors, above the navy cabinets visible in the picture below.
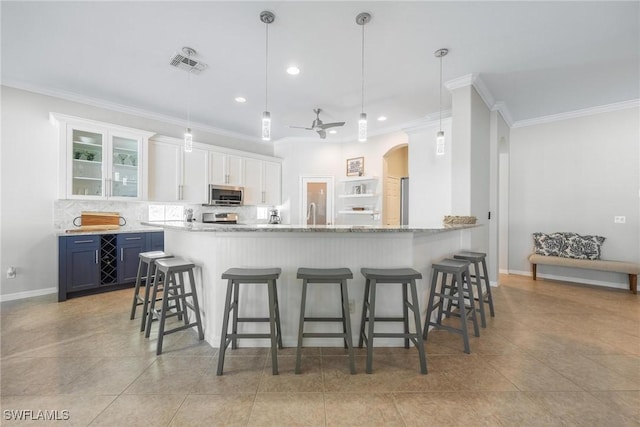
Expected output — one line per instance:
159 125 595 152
52 114 153 200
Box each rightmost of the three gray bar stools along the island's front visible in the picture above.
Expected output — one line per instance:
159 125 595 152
358 268 427 374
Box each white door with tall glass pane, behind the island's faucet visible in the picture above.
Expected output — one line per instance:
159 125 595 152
300 176 334 225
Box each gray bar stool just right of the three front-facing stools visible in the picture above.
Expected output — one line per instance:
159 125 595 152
422 259 480 353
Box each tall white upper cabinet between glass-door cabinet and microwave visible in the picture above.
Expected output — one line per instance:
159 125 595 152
149 137 209 203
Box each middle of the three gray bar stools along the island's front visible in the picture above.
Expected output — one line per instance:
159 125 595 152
295 268 356 374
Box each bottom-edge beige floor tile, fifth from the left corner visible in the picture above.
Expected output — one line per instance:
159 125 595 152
324 393 404 427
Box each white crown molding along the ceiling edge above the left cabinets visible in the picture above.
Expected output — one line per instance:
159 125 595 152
2 79 264 144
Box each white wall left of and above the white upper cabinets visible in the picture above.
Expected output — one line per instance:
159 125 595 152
0 86 273 296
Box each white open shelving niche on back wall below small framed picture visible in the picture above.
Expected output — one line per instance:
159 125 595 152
338 176 380 219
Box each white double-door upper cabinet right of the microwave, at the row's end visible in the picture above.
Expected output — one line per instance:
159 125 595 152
243 158 282 206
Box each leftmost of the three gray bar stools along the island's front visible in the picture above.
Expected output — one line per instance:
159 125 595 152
217 268 282 375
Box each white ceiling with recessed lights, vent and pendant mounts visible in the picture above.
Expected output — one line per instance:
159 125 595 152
1 1 640 140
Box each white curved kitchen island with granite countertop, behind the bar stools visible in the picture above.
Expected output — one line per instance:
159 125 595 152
145 222 478 347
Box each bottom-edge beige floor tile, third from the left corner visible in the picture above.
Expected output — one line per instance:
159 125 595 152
169 393 255 427
